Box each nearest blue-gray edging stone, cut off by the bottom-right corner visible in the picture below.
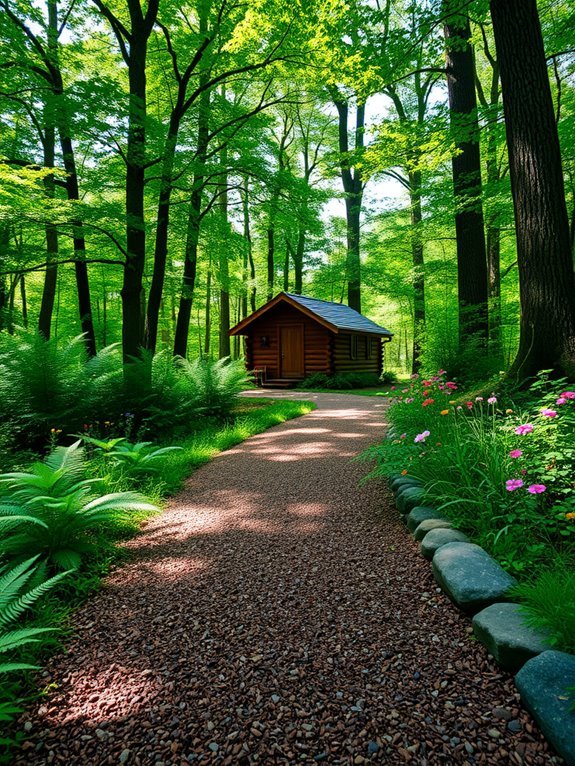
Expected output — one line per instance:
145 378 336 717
515 650 575 766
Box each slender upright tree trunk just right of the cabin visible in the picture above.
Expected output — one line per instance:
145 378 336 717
409 170 425 373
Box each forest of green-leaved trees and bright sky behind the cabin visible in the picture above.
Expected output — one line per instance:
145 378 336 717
0 0 575 375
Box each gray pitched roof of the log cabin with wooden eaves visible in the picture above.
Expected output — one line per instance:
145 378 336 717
230 293 393 338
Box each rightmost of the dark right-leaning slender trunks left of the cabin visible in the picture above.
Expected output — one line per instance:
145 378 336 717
174 90 210 357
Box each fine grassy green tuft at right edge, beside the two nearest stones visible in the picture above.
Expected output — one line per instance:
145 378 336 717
513 557 575 654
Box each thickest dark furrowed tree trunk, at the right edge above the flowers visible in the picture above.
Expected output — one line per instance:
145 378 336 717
490 0 575 381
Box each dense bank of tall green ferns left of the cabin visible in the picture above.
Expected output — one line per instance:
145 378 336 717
0 332 249 448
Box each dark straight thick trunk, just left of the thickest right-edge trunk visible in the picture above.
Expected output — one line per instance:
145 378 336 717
445 8 488 348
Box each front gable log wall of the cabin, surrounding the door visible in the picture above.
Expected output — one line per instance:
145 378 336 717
246 304 333 378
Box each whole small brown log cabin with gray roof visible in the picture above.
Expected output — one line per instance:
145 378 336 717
230 293 393 384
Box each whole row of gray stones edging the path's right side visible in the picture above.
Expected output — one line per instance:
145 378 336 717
389 468 575 766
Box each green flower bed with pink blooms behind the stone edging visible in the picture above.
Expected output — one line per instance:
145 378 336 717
366 373 575 575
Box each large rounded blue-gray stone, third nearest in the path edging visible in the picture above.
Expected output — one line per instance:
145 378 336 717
432 544 515 614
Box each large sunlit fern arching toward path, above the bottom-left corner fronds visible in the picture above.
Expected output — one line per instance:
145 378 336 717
0 442 158 569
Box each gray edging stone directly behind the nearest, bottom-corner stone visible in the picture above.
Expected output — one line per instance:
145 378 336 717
473 604 548 673
